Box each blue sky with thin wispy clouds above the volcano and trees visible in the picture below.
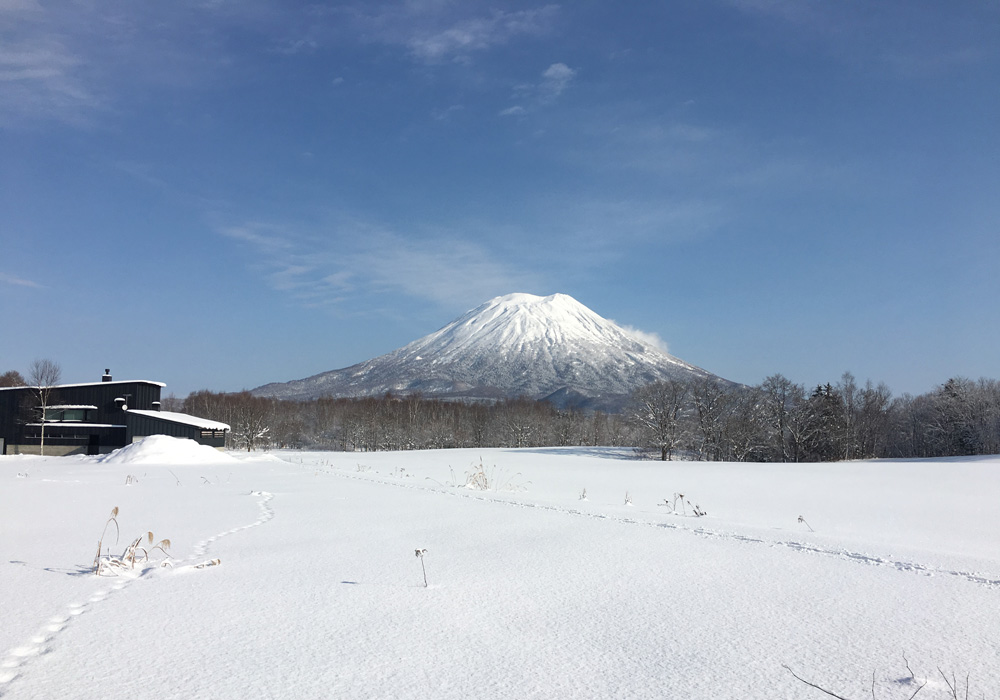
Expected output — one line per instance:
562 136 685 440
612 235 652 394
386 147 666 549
0 0 1000 396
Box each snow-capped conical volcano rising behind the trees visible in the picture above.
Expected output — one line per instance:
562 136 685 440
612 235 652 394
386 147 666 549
253 294 728 410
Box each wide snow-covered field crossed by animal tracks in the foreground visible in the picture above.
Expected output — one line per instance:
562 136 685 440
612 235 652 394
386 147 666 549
0 438 1000 700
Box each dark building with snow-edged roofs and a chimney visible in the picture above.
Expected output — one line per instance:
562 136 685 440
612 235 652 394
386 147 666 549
0 370 229 456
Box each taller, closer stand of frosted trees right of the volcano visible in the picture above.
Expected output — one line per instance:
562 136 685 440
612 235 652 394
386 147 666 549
629 372 1000 462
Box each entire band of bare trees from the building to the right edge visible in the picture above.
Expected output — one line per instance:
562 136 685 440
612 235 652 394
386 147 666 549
174 373 1000 462
